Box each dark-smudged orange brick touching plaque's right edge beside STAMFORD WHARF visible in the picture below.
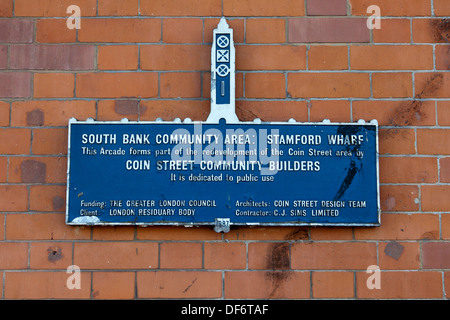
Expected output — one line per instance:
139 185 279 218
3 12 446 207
378 128 416 154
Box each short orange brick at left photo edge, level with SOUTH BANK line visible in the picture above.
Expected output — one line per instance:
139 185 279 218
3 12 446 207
0 128 31 154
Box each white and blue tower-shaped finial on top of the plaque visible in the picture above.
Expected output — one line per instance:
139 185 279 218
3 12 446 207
206 17 239 123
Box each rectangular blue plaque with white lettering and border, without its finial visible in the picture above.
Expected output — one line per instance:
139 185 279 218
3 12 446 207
66 120 380 227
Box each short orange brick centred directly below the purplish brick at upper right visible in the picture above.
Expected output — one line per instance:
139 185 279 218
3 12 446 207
308 45 348 70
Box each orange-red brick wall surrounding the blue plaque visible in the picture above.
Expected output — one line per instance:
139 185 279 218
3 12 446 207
0 0 450 299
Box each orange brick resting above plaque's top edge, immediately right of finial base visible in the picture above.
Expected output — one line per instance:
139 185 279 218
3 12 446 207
236 100 308 122
